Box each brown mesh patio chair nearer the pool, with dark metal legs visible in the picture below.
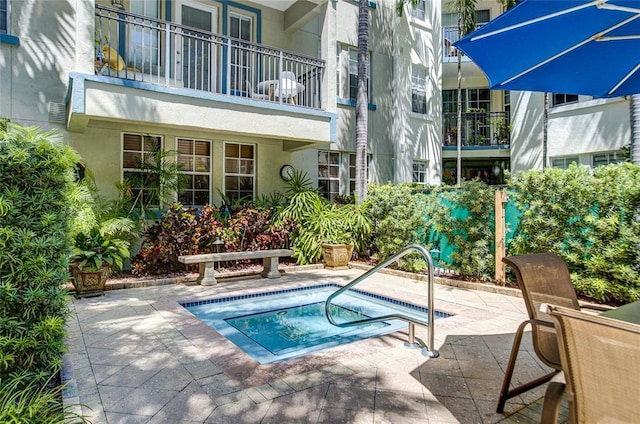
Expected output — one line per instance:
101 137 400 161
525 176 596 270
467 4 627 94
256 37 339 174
497 253 596 413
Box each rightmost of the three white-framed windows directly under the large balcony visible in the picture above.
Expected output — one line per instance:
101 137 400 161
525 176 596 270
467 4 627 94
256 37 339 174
224 143 255 200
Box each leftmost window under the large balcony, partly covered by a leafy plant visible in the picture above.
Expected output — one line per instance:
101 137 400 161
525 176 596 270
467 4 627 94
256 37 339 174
122 134 162 207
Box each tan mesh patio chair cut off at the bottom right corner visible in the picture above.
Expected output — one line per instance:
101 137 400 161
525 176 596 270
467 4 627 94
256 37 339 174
542 305 640 423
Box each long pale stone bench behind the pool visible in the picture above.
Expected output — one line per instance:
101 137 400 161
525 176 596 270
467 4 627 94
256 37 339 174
178 249 293 286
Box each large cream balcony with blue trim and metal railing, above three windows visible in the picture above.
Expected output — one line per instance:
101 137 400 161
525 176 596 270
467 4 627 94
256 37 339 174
69 5 337 150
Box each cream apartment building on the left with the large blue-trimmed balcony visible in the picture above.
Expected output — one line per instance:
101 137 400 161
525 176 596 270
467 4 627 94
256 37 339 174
0 0 443 206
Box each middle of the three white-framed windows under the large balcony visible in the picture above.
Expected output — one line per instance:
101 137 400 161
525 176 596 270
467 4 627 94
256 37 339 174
178 138 211 206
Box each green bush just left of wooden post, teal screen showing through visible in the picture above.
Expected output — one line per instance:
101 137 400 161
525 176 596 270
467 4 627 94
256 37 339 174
423 180 494 279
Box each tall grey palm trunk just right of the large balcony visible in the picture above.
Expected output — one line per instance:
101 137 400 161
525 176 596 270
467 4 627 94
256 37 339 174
356 0 369 204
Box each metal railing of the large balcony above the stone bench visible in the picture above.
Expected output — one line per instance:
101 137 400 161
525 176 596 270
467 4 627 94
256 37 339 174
95 5 325 109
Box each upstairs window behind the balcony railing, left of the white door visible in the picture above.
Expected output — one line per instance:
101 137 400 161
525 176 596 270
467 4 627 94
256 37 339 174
127 0 160 72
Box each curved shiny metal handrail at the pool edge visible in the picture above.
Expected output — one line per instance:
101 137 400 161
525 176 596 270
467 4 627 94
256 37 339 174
324 244 440 358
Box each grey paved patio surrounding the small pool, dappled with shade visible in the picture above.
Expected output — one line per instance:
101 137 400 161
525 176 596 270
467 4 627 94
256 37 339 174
64 270 568 424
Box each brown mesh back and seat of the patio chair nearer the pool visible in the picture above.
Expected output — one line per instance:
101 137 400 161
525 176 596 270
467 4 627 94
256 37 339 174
503 253 580 369
